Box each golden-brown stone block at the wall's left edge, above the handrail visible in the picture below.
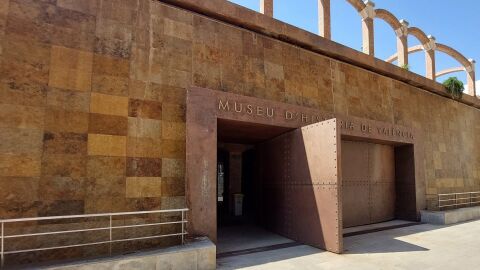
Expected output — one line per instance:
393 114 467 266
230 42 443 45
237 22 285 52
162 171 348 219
0 154 41 177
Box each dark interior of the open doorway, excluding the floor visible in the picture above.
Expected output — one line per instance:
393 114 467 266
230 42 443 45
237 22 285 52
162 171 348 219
217 119 291 229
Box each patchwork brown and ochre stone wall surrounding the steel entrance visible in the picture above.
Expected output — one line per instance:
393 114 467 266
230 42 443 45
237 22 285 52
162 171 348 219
0 0 480 260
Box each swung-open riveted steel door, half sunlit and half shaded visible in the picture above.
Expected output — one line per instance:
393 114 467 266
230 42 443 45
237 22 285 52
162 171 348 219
258 120 342 253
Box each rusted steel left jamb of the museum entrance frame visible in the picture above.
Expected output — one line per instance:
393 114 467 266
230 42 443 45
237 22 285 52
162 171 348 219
185 89 217 242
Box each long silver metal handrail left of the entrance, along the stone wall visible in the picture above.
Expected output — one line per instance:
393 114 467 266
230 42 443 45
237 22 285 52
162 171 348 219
0 208 188 268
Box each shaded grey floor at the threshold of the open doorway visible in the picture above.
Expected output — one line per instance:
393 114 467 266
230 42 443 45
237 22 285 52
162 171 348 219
217 224 294 254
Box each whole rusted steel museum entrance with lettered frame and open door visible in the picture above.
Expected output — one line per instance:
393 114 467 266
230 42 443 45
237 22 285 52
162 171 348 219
186 87 425 253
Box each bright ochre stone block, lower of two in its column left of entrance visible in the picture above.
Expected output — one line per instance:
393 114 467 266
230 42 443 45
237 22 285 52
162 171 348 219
88 134 127 157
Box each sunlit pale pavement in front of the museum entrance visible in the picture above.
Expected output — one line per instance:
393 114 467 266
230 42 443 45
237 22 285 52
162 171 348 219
217 220 480 270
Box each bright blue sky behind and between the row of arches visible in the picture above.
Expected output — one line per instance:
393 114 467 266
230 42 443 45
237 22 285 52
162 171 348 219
227 0 480 85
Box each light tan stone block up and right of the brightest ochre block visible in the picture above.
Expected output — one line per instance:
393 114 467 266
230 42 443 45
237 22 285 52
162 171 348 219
128 117 162 139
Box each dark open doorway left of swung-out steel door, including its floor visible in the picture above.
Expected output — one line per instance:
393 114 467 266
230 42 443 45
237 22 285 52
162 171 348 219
217 119 293 256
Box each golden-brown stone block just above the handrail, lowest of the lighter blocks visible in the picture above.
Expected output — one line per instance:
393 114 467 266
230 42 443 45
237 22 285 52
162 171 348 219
126 177 162 198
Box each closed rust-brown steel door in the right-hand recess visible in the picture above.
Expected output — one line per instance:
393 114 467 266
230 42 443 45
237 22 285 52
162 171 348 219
342 141 395 228
